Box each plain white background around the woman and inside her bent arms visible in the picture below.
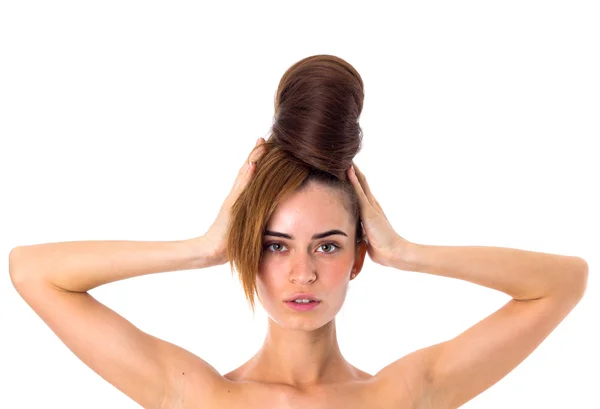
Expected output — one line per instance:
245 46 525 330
0 0 600 409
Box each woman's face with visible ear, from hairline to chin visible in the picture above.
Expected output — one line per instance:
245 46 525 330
256 182 366 330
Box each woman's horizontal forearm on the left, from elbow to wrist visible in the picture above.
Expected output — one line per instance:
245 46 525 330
9 236 218 292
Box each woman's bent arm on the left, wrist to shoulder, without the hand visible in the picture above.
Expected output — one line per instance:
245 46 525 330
9 238 225 409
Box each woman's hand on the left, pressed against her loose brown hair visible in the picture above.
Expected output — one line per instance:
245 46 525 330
198 138 265 265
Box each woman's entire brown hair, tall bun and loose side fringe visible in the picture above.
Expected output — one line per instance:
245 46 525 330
227 55 364 311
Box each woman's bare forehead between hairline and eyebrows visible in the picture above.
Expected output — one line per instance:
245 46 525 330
267 183 352 237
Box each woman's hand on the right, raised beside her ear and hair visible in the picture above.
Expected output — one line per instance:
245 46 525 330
347 162 411 266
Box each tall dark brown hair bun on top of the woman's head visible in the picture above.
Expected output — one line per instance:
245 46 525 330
270 55 364 179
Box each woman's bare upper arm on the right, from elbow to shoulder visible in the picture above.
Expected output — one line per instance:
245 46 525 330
376 286 583 409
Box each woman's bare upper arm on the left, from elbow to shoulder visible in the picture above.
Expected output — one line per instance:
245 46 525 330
11 270 230 408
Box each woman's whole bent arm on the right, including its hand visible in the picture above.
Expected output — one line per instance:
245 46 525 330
349 166 588 409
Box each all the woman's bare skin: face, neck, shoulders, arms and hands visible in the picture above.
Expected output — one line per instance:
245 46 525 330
9 138 588 409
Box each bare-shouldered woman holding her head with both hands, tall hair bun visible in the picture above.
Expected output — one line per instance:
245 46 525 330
10 55 588 409
